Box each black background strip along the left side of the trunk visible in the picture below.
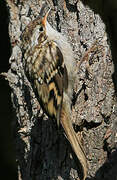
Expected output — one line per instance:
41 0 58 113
0 1 17 180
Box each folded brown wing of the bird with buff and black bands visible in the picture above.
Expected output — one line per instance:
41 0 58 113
35 41 68 126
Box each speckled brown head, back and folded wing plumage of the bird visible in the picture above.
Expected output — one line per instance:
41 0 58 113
22 18 68 125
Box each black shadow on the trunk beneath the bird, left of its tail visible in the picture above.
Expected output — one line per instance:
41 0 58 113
30 117 85 180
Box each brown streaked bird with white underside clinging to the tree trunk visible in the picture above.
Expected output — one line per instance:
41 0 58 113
22 10 88 180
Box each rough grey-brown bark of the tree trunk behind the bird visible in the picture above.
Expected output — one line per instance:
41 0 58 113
3 0 117 180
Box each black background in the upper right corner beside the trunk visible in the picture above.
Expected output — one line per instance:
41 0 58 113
82 0 117 96
